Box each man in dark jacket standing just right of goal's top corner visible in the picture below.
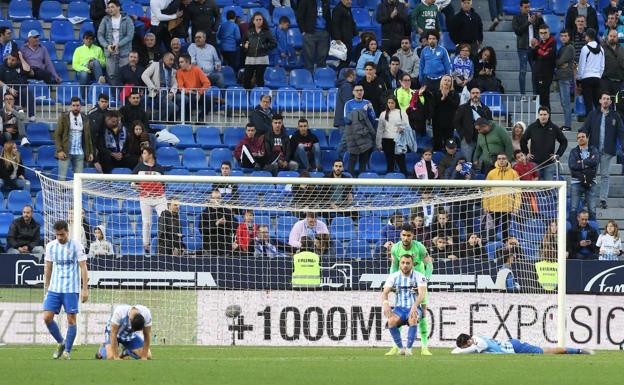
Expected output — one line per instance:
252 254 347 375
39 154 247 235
568 131 600 220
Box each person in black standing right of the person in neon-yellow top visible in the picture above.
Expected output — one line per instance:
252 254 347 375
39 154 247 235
431 75 459 151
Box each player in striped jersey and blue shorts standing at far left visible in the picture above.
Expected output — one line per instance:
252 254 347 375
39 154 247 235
43 221 89 360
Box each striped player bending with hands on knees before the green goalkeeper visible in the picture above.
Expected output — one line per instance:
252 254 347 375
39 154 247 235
382 254 427 356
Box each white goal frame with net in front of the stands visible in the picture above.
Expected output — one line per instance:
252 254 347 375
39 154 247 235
35 172 565 346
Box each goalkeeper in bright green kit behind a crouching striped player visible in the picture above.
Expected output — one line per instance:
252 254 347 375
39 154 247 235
384 224 433 356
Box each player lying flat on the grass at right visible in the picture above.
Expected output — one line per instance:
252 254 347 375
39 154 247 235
451 333 594 354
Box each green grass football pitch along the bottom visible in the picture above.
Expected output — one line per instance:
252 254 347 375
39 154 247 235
0 345 624 385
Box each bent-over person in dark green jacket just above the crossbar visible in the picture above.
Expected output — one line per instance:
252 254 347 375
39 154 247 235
473 118 513 175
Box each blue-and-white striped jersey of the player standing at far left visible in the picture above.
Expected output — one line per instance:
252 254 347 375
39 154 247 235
45 239 87 293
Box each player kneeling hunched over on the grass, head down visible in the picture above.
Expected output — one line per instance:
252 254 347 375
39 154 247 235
95 305 152 360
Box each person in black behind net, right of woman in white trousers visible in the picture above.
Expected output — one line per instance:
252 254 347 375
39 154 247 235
157 199 186 257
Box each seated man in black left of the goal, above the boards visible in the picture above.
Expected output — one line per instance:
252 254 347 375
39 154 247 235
7 205 45 258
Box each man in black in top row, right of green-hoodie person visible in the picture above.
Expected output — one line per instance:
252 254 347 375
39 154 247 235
446 0 483 56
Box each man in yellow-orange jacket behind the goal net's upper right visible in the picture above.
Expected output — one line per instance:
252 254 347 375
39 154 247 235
483 152 522 242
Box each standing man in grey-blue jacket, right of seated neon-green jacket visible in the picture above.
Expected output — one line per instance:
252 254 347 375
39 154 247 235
97 0 135 86
